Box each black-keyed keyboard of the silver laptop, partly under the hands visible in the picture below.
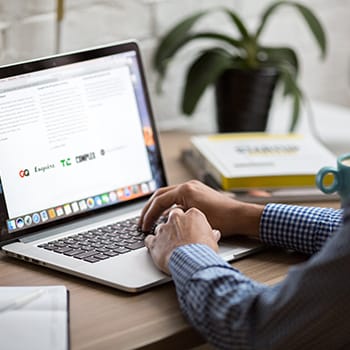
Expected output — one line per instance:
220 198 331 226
38 217 160 263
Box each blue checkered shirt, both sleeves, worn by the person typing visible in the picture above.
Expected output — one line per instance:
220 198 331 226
169 204 350 350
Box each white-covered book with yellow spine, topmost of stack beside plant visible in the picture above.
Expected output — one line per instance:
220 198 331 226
191 132 336 190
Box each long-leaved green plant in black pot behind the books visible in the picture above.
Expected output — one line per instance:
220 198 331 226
153 1 326 132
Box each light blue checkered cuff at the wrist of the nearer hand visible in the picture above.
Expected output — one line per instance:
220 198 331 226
169 244 232 289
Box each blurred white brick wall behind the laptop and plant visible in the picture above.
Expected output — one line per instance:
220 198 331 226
0 0 350 132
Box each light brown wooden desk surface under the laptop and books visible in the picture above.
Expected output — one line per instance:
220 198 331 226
0 132 337 350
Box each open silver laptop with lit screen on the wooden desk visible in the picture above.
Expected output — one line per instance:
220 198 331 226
0 42 257 292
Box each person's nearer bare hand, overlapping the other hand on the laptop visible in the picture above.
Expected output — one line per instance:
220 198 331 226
145 207 220 274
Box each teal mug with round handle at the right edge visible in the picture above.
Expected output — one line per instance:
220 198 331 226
316 153 350 206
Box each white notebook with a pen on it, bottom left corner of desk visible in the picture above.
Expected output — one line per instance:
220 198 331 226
0 286 69 350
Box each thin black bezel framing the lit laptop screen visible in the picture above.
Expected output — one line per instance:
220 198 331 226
0 41 167 246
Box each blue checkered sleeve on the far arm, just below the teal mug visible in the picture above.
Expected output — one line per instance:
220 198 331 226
260 204 343 254
